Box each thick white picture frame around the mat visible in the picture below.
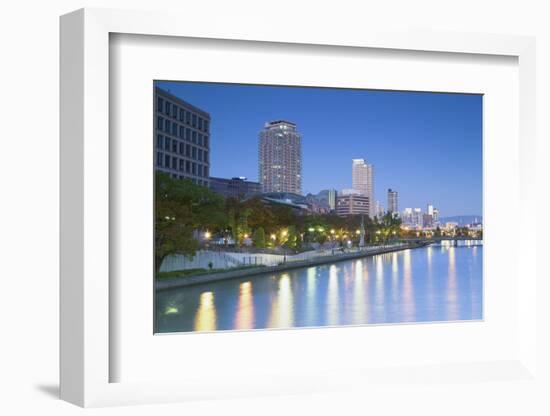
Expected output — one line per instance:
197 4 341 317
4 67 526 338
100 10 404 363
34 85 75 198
60 9 537 407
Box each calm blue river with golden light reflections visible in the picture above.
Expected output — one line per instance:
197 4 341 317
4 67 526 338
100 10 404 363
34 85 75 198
155 242 483 332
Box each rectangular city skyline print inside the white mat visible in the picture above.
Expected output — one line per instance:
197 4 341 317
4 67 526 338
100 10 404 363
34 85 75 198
153 81 483 333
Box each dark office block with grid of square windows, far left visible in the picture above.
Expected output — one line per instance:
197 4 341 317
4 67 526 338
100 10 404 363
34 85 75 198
154 87 210 186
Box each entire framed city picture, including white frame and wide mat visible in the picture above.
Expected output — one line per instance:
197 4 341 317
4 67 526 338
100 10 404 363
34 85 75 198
61 9 537 406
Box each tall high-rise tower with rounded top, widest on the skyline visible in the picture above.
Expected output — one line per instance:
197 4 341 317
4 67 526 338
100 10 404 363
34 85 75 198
258 120 302 194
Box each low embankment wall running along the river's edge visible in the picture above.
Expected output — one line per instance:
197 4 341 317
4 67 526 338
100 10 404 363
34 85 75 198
155 242 430 291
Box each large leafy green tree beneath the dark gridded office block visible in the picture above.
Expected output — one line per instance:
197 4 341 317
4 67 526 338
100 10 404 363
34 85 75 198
155 172 227 272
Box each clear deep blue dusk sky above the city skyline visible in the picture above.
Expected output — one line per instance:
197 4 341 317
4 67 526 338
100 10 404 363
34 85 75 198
156 82 483 217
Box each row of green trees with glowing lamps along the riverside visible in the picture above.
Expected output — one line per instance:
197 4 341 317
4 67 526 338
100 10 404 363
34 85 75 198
155 172 401 271
